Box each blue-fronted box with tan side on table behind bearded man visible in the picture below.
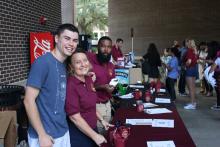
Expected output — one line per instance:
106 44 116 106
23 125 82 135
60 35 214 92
115 68 143 84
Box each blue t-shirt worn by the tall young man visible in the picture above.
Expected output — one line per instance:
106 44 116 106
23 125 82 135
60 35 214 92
27 53 68 138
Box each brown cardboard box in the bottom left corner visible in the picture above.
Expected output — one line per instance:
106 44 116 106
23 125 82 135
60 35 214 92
0 111 17 147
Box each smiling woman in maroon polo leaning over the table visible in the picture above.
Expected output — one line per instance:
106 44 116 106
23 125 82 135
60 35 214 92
65 50 112 147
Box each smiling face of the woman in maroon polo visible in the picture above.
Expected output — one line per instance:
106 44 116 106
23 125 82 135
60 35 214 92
70 53 90 77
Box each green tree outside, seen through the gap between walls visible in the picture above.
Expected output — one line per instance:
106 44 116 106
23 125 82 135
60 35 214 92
77 0 108 35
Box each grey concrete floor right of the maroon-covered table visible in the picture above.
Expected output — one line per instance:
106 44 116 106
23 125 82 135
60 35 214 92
176 90 220 147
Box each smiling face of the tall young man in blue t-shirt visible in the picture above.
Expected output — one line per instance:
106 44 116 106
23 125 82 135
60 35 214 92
55 30 79 57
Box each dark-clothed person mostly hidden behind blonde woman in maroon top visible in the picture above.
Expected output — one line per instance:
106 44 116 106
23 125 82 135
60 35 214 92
178 39 189 96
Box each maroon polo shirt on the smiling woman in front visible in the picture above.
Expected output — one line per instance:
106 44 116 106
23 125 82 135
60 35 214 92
65 76 97 129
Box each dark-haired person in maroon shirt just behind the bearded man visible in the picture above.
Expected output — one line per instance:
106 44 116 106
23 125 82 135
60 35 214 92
112 38 123 62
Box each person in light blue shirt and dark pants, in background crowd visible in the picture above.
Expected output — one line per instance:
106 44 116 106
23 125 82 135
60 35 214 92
163 47 180 101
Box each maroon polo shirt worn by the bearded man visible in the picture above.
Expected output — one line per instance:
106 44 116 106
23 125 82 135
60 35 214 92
87 52 115 103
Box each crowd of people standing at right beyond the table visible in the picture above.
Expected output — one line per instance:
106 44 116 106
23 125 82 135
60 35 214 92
142 39 220 110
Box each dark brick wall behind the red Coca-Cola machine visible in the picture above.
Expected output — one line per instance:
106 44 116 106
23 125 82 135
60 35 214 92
0 0 61 84
